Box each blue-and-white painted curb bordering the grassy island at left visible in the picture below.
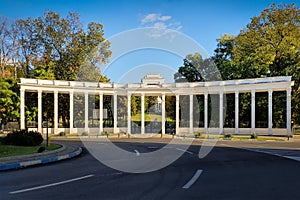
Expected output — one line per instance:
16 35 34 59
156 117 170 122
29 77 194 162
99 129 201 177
0 147 82 171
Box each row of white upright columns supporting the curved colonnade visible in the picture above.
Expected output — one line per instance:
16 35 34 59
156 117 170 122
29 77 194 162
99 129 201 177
20 89 291 135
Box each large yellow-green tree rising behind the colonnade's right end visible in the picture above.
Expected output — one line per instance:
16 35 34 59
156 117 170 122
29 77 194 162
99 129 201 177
231 4 300 124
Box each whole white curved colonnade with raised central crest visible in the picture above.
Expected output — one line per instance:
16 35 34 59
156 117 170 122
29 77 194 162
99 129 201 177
20 74 294 136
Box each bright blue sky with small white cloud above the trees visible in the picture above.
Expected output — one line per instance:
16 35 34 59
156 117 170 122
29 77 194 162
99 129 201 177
0 0 299 82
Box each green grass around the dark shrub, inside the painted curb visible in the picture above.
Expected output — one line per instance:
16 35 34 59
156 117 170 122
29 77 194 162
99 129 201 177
0 143 61 158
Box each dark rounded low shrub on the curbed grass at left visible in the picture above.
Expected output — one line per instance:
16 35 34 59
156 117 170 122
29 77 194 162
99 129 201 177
2 130 43 146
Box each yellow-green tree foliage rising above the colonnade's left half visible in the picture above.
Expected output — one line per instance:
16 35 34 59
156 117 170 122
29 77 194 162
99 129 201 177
15 11 111 81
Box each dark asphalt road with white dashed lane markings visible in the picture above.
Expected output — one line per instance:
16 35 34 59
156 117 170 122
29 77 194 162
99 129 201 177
0 140 300 200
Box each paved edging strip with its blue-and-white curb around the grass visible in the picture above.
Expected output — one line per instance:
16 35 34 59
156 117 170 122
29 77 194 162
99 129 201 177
0 144 82 171
